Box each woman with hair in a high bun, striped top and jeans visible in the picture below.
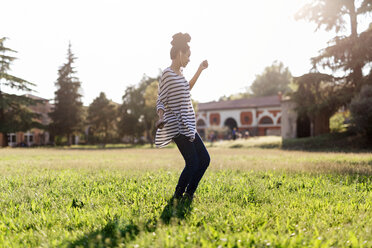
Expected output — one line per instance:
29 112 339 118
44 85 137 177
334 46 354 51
155 33 210 201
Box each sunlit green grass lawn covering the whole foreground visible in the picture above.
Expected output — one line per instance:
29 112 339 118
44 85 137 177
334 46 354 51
0 145 372 247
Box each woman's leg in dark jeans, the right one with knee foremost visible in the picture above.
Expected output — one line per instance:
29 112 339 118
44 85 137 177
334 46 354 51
186 133 211 197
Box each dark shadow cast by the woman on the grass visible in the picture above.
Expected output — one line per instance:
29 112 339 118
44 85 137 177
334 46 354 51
67 197 192 248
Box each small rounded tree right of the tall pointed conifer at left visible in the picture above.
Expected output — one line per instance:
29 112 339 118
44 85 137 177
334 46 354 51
87 92 117 143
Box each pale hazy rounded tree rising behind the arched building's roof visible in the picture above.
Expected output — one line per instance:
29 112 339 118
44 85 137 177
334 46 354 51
251 61 292 96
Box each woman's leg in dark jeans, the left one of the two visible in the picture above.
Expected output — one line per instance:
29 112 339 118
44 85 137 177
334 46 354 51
173 134 199 198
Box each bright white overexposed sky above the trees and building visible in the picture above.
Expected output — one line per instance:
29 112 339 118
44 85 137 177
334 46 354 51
0 0 366 106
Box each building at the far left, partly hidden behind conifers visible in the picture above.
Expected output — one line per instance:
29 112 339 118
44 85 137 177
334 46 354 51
0 94 53 146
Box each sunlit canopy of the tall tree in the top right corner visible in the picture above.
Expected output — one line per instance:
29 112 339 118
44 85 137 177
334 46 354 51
294 0 372 134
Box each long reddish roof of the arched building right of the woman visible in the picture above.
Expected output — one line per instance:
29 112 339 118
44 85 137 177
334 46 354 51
198 95 280 111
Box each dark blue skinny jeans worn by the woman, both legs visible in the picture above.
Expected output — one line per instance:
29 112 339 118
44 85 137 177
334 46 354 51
173 133 210 197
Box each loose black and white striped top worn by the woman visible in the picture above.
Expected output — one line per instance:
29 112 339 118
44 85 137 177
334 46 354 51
155 67 196 148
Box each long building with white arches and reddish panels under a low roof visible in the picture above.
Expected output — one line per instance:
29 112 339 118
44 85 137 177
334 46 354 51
196 95 282 137
